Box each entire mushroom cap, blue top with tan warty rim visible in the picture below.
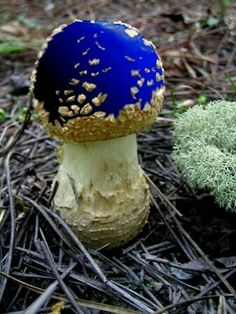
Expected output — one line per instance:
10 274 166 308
31 20 164 142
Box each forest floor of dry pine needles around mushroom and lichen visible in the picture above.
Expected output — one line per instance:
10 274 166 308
0 0 236 314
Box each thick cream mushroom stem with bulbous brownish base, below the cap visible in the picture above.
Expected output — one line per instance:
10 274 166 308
54 134 150 247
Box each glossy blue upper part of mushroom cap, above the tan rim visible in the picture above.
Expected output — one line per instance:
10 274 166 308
32 20 164 126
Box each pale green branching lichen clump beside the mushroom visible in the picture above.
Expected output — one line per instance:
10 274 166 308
172 101 236 212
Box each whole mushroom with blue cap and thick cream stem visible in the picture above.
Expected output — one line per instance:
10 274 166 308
31 20 164 248
